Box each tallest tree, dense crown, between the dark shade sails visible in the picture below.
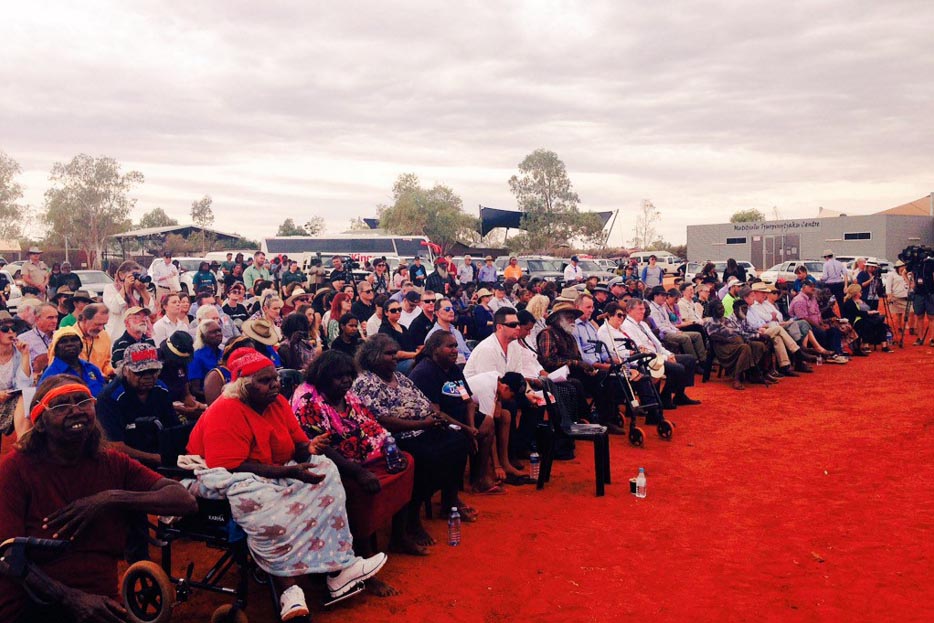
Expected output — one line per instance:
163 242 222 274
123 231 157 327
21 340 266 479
509 149 603 251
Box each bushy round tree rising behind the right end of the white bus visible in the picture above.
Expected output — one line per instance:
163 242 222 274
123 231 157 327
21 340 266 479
379 173 477 251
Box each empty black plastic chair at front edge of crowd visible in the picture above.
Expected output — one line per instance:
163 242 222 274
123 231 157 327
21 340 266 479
536 379 611 497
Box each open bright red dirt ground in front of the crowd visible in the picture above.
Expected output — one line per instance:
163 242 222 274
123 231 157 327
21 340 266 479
165 346 934 623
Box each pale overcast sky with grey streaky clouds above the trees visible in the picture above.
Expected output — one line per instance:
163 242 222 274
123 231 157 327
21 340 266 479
0 0 934 243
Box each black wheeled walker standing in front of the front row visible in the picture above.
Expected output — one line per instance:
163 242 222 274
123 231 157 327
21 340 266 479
594 338 674 447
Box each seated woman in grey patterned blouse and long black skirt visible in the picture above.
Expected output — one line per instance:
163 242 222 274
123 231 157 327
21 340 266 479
352 333 477 528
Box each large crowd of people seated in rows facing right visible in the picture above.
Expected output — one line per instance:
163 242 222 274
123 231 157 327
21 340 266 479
0 252 920 620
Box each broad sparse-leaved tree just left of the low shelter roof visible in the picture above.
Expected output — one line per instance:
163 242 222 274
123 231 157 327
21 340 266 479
44 154 144 268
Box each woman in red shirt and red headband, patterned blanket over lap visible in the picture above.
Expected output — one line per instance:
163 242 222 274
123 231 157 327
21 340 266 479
188 348 387 621
